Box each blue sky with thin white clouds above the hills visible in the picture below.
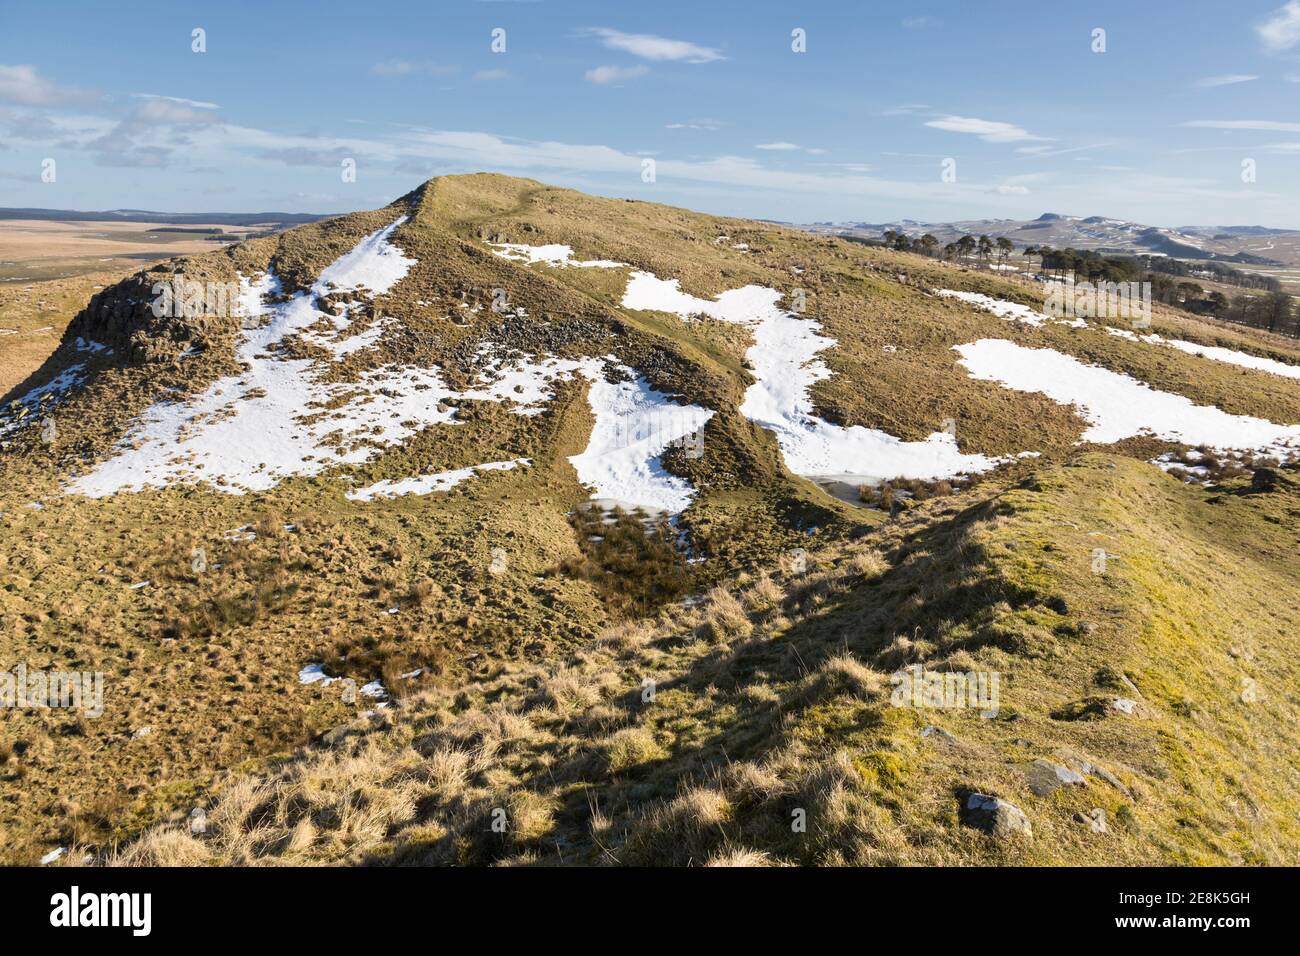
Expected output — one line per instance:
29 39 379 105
0 0 1300 228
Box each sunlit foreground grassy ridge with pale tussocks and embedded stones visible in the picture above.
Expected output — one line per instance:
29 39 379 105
109 455 1300 865
